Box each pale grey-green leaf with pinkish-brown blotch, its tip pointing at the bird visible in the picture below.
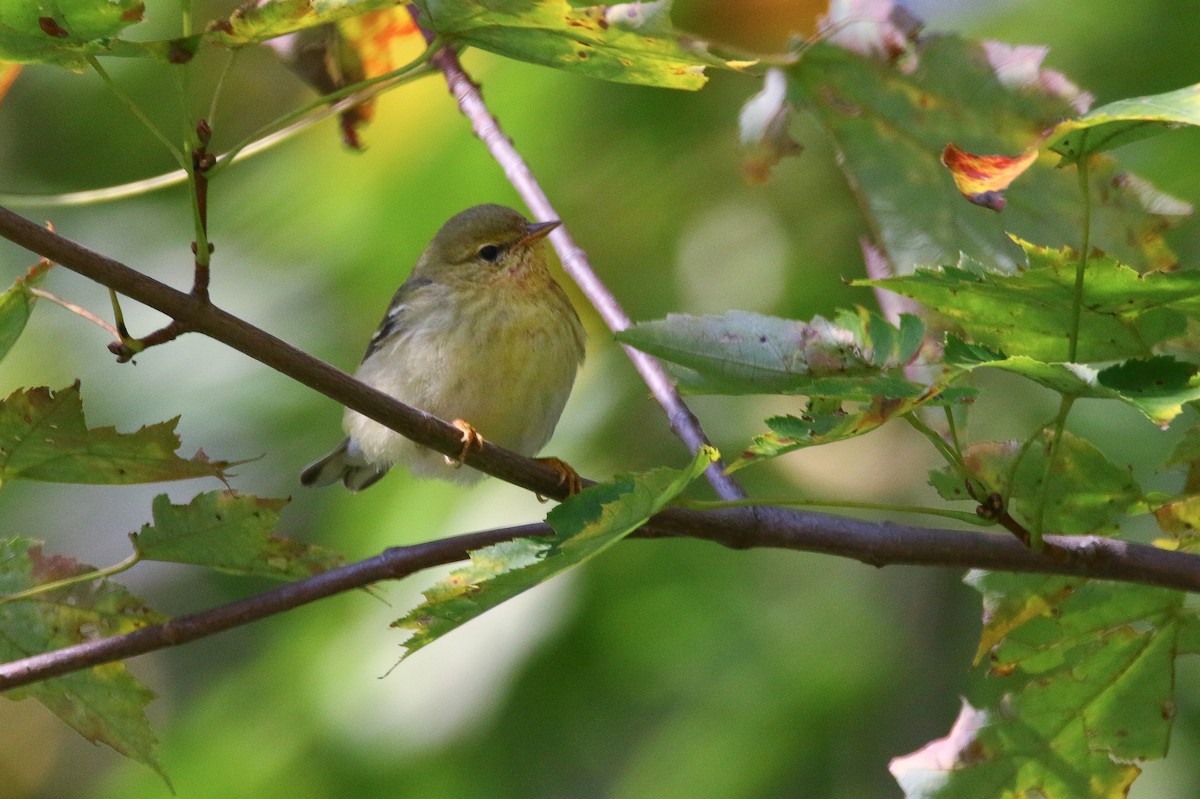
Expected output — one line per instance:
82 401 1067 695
617 311 928 402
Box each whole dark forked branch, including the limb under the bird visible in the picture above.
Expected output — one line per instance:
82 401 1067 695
7 200 1200 689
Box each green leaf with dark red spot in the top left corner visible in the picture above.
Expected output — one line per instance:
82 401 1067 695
0 0 157 68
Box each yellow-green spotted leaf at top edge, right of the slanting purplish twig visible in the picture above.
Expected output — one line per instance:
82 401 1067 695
416 0 752 89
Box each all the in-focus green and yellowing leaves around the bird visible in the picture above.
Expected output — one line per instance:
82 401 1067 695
0 0 1200 797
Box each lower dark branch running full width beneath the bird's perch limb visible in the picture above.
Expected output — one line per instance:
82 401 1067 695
0 507 1200 691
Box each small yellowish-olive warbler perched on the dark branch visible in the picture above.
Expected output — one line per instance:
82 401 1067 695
300 205 584 491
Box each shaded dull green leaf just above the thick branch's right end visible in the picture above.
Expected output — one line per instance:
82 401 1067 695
930 431 1148 535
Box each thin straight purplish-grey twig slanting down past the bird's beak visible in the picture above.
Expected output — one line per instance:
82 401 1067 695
409 6 746 500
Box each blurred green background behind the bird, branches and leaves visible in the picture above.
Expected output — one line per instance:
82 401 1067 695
0 0 1200 799
